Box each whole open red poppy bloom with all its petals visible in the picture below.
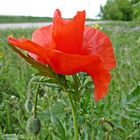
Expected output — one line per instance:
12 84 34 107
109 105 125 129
8 10 116 101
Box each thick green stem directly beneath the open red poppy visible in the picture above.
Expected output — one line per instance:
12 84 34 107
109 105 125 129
68 93 79 140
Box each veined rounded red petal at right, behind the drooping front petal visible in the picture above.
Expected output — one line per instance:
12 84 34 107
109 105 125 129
82 27 116 70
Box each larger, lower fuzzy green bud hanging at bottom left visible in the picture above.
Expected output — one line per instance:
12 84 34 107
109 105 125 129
26 116 41 135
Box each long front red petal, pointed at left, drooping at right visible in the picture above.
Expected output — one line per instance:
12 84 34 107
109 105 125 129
9 38 111 101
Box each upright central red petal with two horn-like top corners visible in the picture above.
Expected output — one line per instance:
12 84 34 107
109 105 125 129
53 10 85 53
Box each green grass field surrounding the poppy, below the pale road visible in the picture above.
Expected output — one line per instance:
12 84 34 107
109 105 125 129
0 23 140 140
